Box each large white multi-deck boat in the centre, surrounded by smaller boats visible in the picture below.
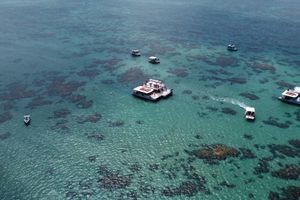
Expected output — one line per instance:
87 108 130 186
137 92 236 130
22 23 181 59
132 79 173 101
